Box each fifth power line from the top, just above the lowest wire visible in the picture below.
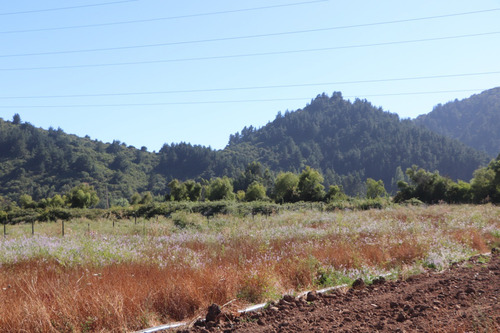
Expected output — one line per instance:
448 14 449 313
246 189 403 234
0 71 500 99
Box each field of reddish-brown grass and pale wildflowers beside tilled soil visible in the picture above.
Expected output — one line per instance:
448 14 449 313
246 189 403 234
0 205 500 332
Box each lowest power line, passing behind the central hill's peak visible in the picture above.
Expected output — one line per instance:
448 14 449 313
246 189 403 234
0 89 485 109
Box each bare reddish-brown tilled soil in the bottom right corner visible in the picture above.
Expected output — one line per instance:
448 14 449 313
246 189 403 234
182 250 500 333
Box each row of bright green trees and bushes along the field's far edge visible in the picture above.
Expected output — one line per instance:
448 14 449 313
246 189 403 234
0 155 500 223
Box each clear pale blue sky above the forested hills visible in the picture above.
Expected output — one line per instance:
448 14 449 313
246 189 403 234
0 0 500 151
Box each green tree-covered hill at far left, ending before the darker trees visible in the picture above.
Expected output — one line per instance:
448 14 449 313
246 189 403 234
0 117 157 206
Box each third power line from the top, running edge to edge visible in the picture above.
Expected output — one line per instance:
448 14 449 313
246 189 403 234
0 8 500 58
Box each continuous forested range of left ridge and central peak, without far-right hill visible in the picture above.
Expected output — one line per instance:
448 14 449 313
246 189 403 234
0 93 489 207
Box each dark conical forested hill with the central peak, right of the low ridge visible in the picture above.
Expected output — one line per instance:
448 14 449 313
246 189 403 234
226 93 489 193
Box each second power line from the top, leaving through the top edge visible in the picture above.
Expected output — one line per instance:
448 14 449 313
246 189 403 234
0 0 330 34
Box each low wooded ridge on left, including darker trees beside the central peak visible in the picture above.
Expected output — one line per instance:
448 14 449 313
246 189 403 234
0 116 246 207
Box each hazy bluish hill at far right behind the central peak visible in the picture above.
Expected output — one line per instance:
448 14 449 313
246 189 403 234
415 87 500 157
